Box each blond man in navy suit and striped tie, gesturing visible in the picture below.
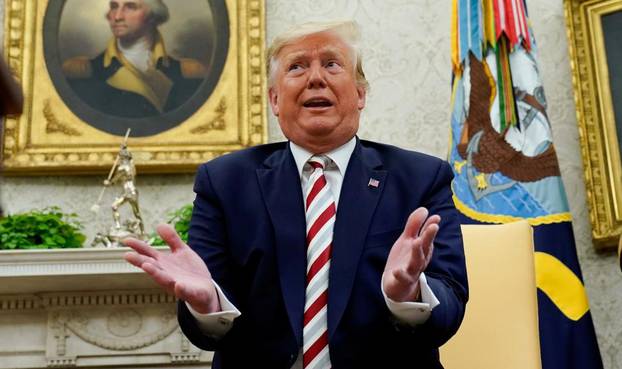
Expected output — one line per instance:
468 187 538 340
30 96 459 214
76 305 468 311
126 22 467 368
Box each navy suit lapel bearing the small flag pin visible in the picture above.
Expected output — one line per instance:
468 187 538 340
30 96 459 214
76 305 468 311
328 140 387 338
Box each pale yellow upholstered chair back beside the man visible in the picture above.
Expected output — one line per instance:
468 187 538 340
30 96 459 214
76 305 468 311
441 221 542 369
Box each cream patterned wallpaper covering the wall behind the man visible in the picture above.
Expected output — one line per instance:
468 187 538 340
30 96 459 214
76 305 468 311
0 0 622 369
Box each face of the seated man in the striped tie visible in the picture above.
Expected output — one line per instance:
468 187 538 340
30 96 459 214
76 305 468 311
269 32 365 153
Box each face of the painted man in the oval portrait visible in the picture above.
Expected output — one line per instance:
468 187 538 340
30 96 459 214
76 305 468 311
106 0 152 41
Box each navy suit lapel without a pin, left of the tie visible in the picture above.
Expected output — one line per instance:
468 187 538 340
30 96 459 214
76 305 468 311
257 146 306 347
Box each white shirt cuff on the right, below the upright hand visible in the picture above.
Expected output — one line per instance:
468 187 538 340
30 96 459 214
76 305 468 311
380 273 440 326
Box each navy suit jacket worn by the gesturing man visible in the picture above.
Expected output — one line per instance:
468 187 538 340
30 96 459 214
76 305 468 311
178 139 468 369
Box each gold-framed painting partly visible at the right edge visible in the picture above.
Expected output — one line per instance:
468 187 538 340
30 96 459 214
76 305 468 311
564 0 622 249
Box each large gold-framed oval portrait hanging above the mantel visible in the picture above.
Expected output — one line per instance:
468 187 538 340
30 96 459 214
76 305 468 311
2 0 267 175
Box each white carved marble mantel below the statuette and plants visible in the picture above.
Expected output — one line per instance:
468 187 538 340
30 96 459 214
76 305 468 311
0 248 212 369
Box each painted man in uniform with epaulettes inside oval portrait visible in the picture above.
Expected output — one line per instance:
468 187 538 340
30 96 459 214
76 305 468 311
63 0 207 118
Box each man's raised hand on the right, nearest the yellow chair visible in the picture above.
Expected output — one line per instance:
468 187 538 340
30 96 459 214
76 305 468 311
382 207 441 302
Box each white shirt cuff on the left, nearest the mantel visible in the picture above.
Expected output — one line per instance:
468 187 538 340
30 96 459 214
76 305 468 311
185 281 242 339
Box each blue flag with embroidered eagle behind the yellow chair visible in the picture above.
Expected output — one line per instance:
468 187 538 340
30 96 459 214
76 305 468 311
449 0 603 369
